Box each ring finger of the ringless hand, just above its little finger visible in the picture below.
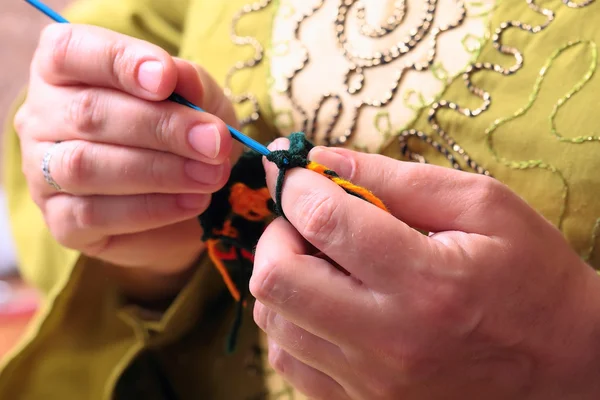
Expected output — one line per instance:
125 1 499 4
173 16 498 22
254 301 347 377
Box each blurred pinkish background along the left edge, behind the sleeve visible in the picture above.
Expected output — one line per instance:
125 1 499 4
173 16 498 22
0 0 69 359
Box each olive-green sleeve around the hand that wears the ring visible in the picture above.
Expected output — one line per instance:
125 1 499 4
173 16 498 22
0 0 231 398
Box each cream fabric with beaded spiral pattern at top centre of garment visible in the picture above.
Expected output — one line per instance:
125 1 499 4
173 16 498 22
273 0 493 151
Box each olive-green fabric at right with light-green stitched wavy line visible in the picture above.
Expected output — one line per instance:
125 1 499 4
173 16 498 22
384 1 600 268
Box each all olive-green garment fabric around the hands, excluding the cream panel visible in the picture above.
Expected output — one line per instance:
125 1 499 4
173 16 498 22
0 0 600 400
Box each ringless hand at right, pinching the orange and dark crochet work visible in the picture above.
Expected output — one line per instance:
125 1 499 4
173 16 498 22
250 140 600 400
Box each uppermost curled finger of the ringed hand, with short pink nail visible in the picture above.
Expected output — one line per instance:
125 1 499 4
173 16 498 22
32 24 177 101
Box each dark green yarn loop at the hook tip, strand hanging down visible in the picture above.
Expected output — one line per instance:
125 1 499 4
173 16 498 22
267 132 313 219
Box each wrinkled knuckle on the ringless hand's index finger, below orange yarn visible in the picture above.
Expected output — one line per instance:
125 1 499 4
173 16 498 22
299 192 340 242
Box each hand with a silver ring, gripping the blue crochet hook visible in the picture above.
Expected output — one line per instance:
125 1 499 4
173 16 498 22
15 24 240 296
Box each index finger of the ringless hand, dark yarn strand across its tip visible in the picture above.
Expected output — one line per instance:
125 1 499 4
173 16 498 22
265 141 434 290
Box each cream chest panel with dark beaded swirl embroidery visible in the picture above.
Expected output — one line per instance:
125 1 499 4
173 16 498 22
271 0 494 152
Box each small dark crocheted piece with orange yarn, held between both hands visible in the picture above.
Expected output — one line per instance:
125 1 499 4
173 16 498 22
198 132 388 352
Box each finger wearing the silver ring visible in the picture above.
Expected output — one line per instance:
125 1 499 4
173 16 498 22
31 140 230 197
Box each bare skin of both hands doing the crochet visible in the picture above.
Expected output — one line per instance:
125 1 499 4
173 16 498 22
15 25 600 400
